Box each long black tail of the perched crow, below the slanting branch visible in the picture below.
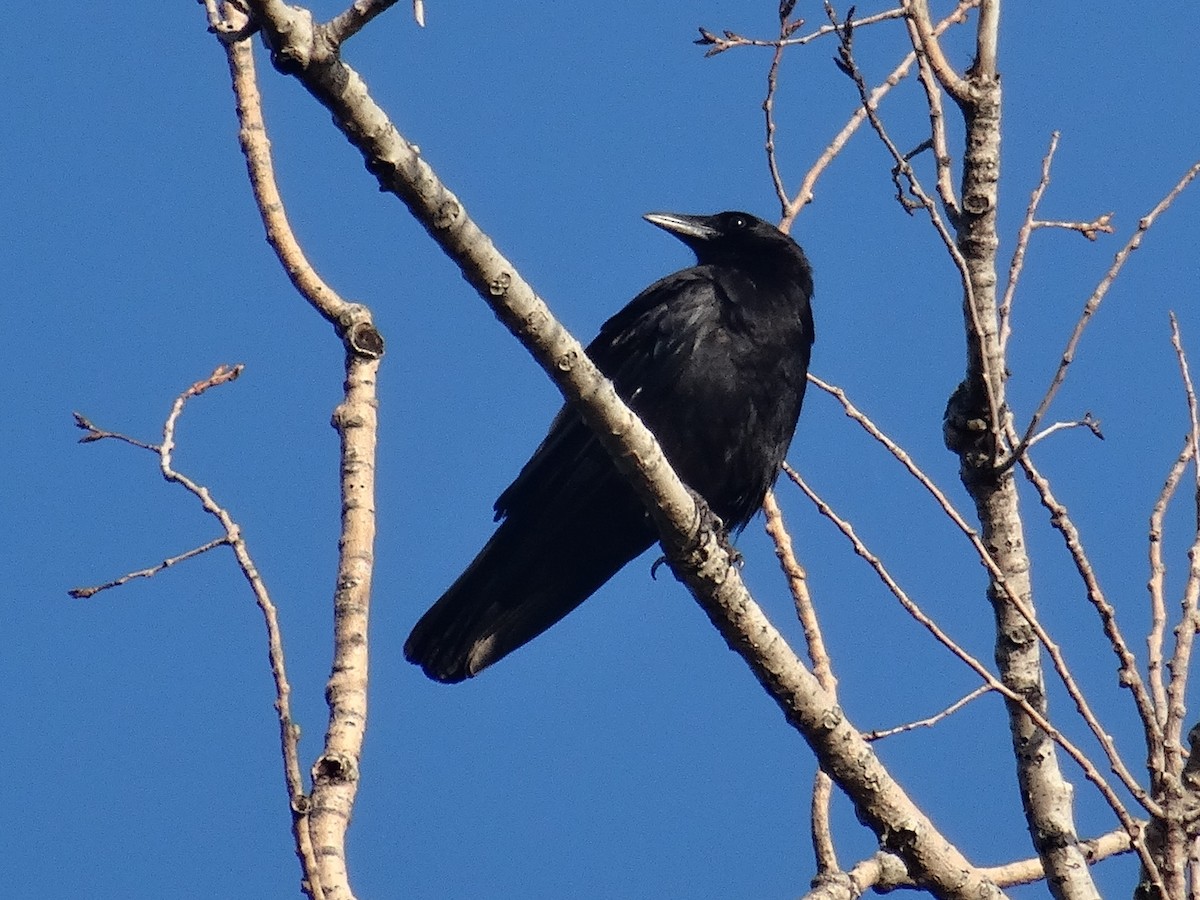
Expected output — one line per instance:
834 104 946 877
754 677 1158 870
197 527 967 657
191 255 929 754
404 520 653 683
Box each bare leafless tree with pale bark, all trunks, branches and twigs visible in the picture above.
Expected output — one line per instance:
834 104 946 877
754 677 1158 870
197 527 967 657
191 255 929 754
76 0 1200 900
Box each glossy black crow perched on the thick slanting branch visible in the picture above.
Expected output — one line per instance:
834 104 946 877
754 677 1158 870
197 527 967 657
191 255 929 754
404 212 812 682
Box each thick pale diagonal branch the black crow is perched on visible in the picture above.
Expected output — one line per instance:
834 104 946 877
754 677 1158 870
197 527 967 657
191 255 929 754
236 0 1000 898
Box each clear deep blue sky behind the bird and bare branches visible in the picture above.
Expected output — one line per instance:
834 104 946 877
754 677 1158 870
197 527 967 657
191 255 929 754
9 0 1200 899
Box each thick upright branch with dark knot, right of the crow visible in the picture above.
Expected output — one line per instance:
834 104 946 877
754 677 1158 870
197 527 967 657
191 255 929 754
905 0 1099 900
